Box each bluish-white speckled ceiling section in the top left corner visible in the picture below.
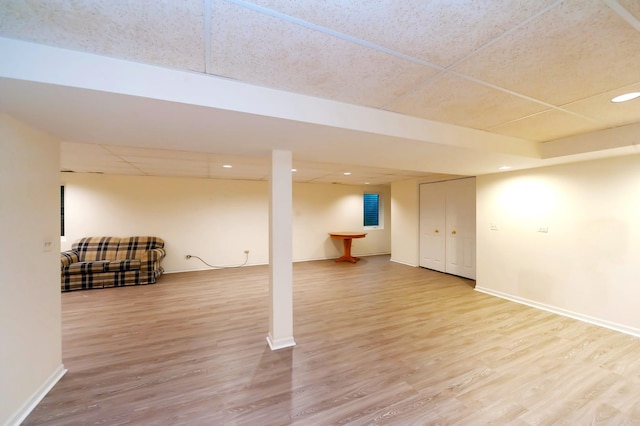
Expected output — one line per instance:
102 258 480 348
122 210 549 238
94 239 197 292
0 0 205 72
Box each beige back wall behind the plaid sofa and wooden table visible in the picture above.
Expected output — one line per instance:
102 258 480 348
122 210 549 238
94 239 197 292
61 173 391 272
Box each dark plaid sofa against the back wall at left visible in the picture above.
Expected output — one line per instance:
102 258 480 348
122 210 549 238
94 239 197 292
60 237 166 291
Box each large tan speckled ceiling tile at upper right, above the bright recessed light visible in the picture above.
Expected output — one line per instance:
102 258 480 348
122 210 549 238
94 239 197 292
455 0 640 105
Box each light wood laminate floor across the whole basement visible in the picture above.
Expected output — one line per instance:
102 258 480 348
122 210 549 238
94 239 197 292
25 256 640 425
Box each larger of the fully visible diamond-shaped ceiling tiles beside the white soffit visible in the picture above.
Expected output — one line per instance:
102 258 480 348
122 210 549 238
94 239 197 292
386 74 548 130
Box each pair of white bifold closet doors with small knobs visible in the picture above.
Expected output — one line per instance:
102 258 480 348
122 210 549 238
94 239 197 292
420 178 476 279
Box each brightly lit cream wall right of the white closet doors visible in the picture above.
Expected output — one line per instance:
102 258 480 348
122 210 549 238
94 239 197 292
477 155 640 334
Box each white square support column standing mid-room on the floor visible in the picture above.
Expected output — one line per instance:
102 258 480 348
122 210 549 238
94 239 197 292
267 150 296 350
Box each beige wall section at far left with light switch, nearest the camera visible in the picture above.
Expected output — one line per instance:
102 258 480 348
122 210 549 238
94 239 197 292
0 113 64 424
